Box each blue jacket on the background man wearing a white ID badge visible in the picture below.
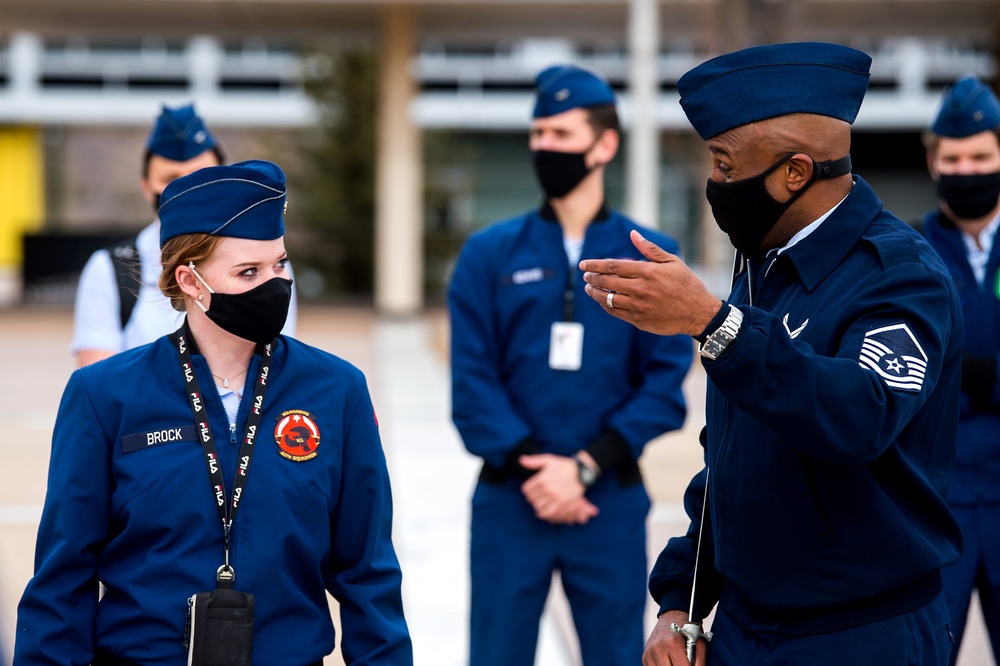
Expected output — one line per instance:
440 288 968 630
448 206 693 467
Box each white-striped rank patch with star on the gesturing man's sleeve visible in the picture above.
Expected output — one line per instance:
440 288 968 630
858 324 927 393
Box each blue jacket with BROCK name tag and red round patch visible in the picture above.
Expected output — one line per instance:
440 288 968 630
14 337 413 666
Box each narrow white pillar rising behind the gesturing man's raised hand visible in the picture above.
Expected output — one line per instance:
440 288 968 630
625 0 660 228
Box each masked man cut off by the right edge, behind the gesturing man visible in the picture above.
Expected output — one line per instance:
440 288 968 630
923 76 1000 664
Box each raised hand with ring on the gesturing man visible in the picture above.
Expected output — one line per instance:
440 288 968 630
580 231 723 335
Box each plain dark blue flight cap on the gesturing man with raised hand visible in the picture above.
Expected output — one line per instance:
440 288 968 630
677 42 872 141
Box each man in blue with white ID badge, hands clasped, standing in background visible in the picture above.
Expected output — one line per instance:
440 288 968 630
448 66 693 666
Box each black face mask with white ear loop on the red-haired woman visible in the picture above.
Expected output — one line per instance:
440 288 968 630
189 264 292 344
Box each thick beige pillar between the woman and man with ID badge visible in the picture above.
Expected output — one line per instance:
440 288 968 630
375 5 424 316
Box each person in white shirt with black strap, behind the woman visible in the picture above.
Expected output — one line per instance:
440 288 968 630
70 104 297 367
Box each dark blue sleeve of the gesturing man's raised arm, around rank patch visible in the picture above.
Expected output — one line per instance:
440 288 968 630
705 263 962 465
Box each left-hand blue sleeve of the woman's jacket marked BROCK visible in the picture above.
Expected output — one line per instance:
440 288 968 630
14 372 113 666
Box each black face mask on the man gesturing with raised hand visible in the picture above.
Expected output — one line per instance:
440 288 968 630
705 153 851 261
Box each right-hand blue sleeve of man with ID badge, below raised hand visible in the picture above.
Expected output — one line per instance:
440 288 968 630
608 333 694 460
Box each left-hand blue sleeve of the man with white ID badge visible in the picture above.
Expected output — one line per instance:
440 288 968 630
448 236 532 467
